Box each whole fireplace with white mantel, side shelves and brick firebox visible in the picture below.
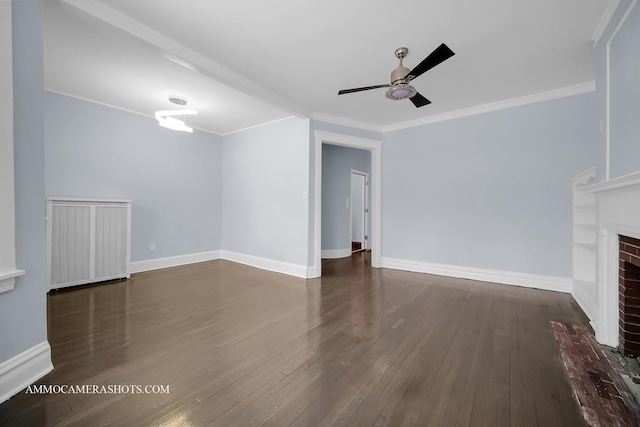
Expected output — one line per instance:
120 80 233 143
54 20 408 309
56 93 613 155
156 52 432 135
571 168 640 357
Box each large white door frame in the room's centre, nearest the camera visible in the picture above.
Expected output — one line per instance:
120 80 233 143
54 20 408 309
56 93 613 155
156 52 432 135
308 130 382 278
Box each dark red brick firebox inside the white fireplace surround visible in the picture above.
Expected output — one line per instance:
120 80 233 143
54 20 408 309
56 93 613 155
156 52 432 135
618 235 640 357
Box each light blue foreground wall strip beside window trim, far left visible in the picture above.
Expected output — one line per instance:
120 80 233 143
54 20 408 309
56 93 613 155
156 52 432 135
0 0 47 363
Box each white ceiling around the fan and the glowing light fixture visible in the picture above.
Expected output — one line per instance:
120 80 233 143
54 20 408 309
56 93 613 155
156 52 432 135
44 0 612 134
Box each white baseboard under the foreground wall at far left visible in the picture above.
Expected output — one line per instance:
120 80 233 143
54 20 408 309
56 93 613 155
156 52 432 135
0 341 53 403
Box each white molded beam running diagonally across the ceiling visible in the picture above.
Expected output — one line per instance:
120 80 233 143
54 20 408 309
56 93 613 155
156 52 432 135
62 0 311 119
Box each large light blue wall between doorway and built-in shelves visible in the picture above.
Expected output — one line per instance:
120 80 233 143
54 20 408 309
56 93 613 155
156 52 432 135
382 93 597 277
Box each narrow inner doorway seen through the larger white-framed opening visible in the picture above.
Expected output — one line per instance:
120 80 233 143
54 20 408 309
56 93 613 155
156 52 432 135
350 169 369 253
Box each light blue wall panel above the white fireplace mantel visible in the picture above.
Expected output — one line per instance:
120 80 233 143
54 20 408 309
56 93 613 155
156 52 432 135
599 2 640 178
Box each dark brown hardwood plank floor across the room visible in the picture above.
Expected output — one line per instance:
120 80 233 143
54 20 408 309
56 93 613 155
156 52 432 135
0 252 586 427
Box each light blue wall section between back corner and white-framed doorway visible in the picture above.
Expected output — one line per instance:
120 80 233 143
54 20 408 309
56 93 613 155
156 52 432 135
222 118 309 266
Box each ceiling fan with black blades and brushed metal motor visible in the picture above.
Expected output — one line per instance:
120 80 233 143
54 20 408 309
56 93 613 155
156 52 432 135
338 43 455 108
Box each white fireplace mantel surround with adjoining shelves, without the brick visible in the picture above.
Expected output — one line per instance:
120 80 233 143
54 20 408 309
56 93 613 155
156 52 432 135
572 169 640 347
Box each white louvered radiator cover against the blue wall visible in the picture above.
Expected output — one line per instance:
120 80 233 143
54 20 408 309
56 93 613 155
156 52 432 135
47 198 131 289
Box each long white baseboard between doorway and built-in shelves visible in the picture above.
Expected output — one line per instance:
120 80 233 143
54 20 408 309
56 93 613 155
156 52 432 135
382 257 572 293
